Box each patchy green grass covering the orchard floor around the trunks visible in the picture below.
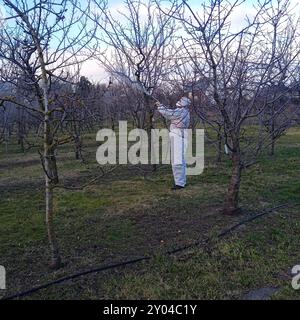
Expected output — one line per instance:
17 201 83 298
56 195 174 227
0 128 300 299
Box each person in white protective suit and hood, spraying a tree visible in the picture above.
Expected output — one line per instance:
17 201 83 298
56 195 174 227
155 97 191 190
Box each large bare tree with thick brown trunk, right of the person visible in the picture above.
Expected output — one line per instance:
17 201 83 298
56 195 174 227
157 0 299 213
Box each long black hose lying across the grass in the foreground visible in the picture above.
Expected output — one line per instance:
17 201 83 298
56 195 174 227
0 202 300 300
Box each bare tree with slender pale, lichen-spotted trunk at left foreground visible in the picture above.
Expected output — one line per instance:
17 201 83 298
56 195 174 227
0 0 101 268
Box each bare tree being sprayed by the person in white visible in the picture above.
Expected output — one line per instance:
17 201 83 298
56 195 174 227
84 0 175 161
